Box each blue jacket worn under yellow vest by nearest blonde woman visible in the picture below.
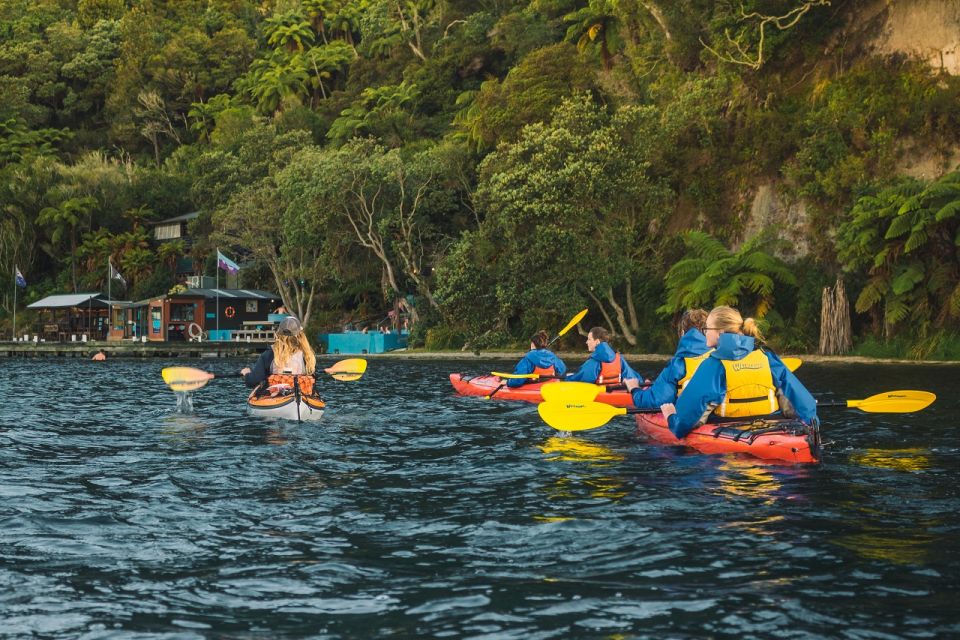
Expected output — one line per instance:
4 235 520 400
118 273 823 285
668 333 817 438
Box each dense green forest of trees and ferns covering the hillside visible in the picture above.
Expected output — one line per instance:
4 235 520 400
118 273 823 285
0 0 960 356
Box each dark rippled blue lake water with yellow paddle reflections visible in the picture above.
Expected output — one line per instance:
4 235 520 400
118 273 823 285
0 360 960 639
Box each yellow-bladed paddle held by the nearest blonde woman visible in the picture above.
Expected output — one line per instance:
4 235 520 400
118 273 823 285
537 382 937 431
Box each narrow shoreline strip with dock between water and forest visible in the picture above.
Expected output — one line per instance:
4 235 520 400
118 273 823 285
0 341 960 366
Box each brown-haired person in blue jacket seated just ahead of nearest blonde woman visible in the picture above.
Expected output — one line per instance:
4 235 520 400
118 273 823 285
623 309 712 409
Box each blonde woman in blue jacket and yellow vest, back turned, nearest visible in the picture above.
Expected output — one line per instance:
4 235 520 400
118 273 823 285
660 306 818 438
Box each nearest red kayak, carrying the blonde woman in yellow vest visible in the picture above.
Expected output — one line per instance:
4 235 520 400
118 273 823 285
636 413 821 462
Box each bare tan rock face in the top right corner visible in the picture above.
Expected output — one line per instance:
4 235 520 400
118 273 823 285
858 0 960 75
